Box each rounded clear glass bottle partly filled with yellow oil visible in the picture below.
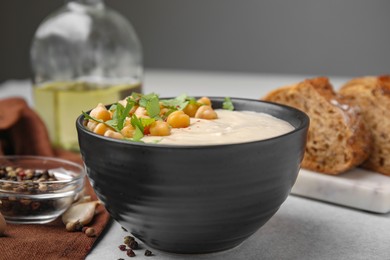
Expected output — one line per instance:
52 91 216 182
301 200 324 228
30 0 143 150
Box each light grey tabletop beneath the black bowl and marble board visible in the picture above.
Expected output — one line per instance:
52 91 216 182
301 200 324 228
0 70 390 260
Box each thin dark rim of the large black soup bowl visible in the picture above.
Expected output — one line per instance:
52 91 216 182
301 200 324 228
76 96 310 149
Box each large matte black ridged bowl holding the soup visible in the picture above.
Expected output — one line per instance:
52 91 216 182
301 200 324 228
77 98 309 253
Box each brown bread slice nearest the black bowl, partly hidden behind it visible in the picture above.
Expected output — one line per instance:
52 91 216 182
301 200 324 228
262 77 371 174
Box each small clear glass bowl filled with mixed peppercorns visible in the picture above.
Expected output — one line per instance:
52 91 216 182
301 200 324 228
0 156 85 224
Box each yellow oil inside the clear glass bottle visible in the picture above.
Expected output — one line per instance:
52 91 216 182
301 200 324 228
34 82 141 151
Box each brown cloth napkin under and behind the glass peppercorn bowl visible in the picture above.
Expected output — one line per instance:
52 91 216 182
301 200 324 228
0 98 110 260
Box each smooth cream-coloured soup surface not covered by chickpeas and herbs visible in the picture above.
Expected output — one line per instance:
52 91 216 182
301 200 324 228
142 109 294 145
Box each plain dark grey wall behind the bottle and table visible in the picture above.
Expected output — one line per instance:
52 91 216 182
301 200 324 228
0 0 390 82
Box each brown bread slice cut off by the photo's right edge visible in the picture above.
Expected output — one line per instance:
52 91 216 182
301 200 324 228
339 75 390 176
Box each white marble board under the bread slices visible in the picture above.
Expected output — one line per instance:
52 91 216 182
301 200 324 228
291 168 390 213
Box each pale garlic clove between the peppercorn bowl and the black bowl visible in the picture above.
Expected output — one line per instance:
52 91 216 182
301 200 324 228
62 201 101 225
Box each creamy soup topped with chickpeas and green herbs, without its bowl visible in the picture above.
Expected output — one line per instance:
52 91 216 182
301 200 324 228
84 93 294 145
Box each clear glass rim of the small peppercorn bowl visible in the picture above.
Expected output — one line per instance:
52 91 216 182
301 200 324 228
0 155 87 184
